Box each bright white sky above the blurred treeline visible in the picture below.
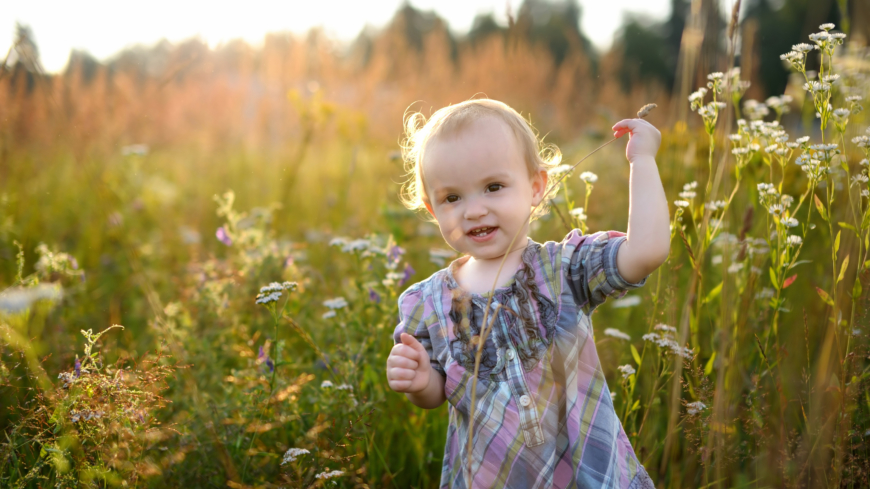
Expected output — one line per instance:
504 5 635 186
0 0 670 72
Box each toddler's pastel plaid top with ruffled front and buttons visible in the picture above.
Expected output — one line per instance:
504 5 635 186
394 230 655 489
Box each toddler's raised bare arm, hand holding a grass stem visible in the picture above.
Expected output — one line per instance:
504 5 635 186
613 119 671 283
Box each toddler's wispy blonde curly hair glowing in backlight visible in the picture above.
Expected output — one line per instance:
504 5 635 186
401 98 562 218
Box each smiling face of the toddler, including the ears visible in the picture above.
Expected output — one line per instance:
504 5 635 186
422 117 547 260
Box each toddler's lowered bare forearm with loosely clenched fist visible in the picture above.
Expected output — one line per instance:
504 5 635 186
387 333 447 409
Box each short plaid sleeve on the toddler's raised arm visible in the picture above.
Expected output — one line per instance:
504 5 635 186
563 229 649 315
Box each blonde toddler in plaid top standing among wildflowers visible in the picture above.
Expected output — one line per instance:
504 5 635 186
387 99 670 489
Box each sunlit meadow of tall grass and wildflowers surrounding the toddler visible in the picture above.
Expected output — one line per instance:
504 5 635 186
0 2 870 488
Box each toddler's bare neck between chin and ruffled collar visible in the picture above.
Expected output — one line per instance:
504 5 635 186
454 236 528 294
